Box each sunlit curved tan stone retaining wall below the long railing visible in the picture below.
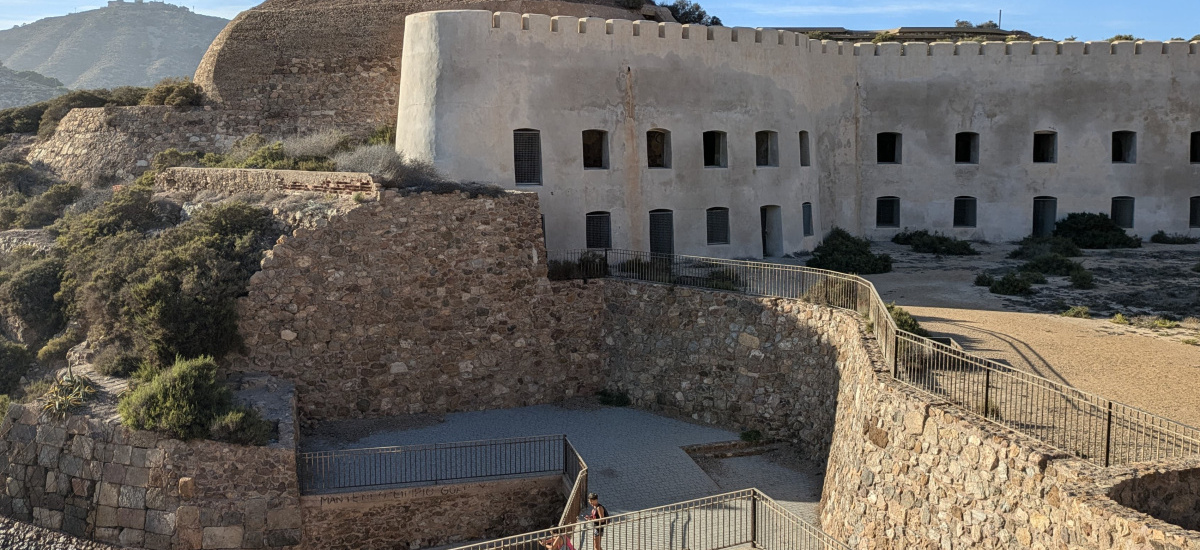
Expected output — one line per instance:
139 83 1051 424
821 314 1200 550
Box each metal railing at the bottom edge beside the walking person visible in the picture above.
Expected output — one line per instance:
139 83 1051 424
460 489 848 550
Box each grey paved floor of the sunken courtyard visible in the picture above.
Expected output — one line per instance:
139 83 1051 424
306 406 822 518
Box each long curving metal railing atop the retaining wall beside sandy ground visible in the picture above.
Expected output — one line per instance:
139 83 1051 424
548 250 1200 467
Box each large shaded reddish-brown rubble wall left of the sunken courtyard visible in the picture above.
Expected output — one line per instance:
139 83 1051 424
232 192 604 422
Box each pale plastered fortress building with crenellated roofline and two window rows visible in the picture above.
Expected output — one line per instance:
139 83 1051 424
397 11 1200 257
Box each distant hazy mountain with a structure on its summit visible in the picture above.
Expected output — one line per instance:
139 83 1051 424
0 2 229 89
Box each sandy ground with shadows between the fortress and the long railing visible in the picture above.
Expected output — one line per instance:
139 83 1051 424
868 243 1200 426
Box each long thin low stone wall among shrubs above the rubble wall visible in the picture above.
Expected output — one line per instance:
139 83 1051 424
155 168 379 198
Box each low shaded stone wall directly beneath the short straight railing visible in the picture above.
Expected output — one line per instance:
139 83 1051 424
300 476 566 550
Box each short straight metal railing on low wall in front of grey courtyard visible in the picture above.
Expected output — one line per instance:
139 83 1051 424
296 435 587 494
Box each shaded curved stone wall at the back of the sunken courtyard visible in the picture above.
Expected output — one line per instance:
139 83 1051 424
604 282 857 467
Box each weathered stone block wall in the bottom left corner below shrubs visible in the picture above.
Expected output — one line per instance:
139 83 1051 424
0 393 301 550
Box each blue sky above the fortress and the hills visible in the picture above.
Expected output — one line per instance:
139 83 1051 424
0 0 1200 40
